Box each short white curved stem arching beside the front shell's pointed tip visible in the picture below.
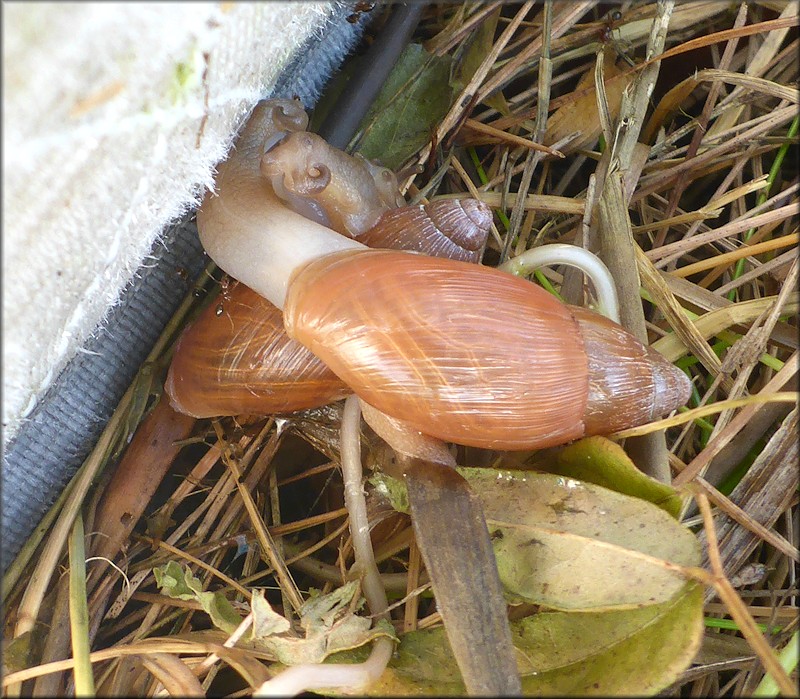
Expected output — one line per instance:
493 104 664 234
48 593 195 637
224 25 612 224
499 243 620 323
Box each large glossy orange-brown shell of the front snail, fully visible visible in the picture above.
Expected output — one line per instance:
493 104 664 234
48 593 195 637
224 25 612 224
284 250 690 450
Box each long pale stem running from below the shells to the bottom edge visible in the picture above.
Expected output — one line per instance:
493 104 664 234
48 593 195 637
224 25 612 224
253 396 394 697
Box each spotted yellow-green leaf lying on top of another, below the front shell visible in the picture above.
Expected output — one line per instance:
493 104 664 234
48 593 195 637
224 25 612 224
459 468 700 611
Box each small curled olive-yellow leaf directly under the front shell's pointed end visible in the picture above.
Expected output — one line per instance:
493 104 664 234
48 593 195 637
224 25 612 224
534 437 681 519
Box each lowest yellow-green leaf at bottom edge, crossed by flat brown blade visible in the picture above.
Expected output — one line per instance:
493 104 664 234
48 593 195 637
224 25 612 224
331 583 703 696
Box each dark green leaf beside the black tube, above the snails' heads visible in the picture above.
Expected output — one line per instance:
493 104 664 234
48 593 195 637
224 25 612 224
356 44 453 170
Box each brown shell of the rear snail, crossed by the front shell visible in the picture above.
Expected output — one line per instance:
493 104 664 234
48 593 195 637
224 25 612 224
164 199 491 418
